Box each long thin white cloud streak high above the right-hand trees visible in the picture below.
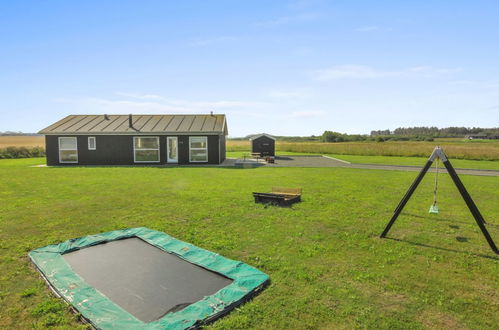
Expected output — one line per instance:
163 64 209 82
313 65 461 81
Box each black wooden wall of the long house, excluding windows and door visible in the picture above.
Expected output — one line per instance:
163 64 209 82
45 135 225 166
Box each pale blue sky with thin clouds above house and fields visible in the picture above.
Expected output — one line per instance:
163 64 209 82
0 0 499 137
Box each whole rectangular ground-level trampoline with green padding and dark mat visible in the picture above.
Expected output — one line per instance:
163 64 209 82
29 228 269 329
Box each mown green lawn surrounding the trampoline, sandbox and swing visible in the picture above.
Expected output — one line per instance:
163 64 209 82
0 159 499 329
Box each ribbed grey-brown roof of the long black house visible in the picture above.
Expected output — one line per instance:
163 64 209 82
38 115 228 135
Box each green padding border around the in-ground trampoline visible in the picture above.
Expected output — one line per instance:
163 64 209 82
29 228 269 329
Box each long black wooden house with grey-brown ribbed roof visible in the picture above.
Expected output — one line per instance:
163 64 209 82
39 114 227 165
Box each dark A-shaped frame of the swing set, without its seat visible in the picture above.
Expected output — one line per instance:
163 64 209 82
380 147 499 254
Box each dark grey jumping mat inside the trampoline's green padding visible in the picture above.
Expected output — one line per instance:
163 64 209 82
63 237 232 322
